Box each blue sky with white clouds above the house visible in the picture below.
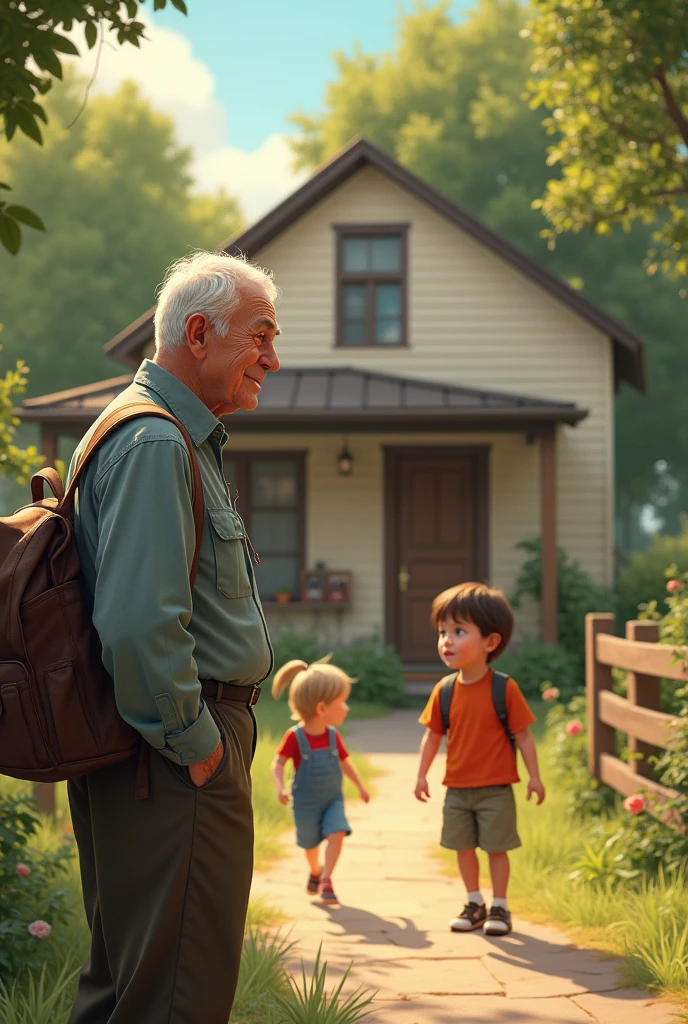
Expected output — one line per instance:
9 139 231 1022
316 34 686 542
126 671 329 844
76 0 473 221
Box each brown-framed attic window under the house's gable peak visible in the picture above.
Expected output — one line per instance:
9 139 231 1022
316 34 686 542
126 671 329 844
336 224 406 348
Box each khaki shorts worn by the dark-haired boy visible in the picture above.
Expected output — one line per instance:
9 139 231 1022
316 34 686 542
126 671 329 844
439 785 521 853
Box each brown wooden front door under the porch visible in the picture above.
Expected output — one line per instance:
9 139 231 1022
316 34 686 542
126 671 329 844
387 447 487 664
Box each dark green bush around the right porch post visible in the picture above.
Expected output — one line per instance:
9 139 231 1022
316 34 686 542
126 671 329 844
512 538 615 671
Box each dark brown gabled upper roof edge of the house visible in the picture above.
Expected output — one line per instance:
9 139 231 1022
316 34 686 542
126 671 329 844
105 139 645 391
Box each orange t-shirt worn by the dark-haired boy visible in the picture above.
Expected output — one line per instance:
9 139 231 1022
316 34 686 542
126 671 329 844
419 669 535 790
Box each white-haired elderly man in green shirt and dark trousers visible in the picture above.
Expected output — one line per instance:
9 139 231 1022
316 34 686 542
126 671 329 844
64 253 280 1024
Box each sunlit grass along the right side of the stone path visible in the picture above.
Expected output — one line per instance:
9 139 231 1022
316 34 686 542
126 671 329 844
433 739 688 1007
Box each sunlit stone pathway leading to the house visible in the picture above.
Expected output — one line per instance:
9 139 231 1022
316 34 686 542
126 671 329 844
254 711 674 1024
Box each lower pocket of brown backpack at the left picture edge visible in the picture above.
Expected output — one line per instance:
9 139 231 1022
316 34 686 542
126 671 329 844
0 662 52 777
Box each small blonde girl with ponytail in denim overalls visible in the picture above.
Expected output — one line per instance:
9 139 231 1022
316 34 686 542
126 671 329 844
272 656 371 904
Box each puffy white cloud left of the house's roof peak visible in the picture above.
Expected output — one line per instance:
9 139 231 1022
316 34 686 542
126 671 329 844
69 15 307 222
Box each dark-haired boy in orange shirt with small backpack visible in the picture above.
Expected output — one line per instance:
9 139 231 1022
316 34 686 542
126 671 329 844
416 583 545 935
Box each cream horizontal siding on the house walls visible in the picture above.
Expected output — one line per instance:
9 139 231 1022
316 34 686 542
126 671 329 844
255 161 613 593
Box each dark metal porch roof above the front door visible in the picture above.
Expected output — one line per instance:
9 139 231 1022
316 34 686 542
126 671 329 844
18 367 588 433
